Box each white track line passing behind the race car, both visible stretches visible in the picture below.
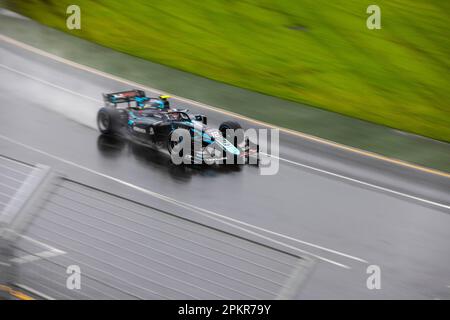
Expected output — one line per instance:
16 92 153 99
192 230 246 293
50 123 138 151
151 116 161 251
0 63 450 209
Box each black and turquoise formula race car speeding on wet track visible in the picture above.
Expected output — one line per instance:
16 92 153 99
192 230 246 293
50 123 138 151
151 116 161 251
97 90 259 165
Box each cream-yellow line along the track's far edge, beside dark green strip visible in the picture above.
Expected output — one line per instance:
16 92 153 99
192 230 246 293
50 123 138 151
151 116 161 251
0 34 450 178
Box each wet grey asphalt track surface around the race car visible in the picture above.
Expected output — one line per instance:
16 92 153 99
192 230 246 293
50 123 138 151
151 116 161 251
0 38 450 299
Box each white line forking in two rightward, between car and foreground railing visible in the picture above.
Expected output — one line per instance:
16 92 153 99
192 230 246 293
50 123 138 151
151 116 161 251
0 134 368 269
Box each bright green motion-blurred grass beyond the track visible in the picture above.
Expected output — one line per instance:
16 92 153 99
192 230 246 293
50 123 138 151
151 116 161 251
3 0 450 142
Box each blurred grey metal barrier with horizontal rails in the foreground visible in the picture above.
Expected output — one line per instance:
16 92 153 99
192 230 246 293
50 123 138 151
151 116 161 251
0 157 314 299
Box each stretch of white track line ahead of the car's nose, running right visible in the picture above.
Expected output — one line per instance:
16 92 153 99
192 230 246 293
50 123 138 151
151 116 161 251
261 153 450 209
